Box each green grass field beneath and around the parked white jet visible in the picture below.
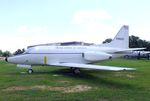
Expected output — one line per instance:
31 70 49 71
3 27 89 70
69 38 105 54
0 59 150 101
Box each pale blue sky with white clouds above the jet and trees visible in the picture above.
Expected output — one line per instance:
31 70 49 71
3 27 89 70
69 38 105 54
0 0 150 52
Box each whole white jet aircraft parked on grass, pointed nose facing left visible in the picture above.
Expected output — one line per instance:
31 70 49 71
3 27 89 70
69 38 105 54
5 25 143 73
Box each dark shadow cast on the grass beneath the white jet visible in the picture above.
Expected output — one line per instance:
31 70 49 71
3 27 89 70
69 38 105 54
31 69 139 89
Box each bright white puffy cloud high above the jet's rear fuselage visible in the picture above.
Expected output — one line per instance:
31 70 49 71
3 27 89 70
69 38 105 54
72 9 112 24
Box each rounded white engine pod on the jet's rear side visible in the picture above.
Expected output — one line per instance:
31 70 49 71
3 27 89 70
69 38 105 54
83 51 112 61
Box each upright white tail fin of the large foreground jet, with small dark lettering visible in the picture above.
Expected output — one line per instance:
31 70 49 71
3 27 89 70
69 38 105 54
101 25 129 48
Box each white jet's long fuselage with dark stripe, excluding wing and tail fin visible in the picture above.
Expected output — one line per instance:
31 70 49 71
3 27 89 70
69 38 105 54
8 46 123 65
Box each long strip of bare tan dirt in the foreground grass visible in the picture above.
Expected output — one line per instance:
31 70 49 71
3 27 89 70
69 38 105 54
3 85 92 93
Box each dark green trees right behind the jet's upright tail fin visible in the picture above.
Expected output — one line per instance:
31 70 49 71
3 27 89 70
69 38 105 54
103 35 150 51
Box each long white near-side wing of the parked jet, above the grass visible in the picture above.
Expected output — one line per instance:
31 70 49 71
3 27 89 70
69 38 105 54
51 63 135 71
